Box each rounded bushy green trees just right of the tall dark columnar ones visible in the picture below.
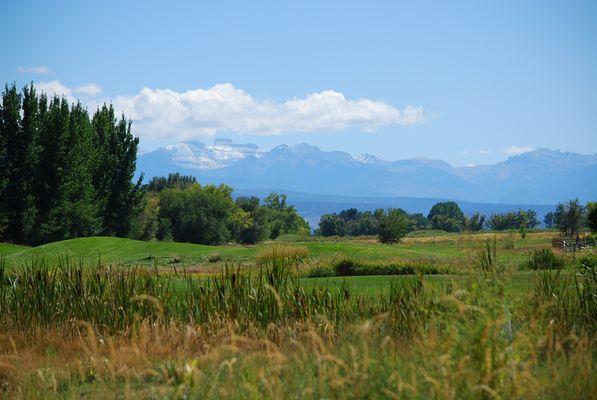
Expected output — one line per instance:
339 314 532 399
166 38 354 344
135 173 310 244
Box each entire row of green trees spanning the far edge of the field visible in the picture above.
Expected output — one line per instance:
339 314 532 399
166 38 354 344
0 84 597 244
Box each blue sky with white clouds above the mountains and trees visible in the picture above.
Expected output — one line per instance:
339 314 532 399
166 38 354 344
0 0 597 165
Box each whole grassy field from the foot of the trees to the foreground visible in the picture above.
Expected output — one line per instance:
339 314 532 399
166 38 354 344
0 232 597 399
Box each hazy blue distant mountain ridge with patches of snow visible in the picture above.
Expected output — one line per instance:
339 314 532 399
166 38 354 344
137 139 597 204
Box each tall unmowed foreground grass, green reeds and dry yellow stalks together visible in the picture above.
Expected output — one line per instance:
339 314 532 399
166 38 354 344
0 252 597 399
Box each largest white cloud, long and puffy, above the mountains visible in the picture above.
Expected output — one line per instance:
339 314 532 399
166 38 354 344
108 83 425 140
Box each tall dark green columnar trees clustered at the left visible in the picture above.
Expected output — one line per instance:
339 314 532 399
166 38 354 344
0 84 143 244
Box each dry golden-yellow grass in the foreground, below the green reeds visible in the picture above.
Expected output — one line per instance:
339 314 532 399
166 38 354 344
0 310 597 399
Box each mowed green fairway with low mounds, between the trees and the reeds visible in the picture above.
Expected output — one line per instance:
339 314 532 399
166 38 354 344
0 232 556 272
